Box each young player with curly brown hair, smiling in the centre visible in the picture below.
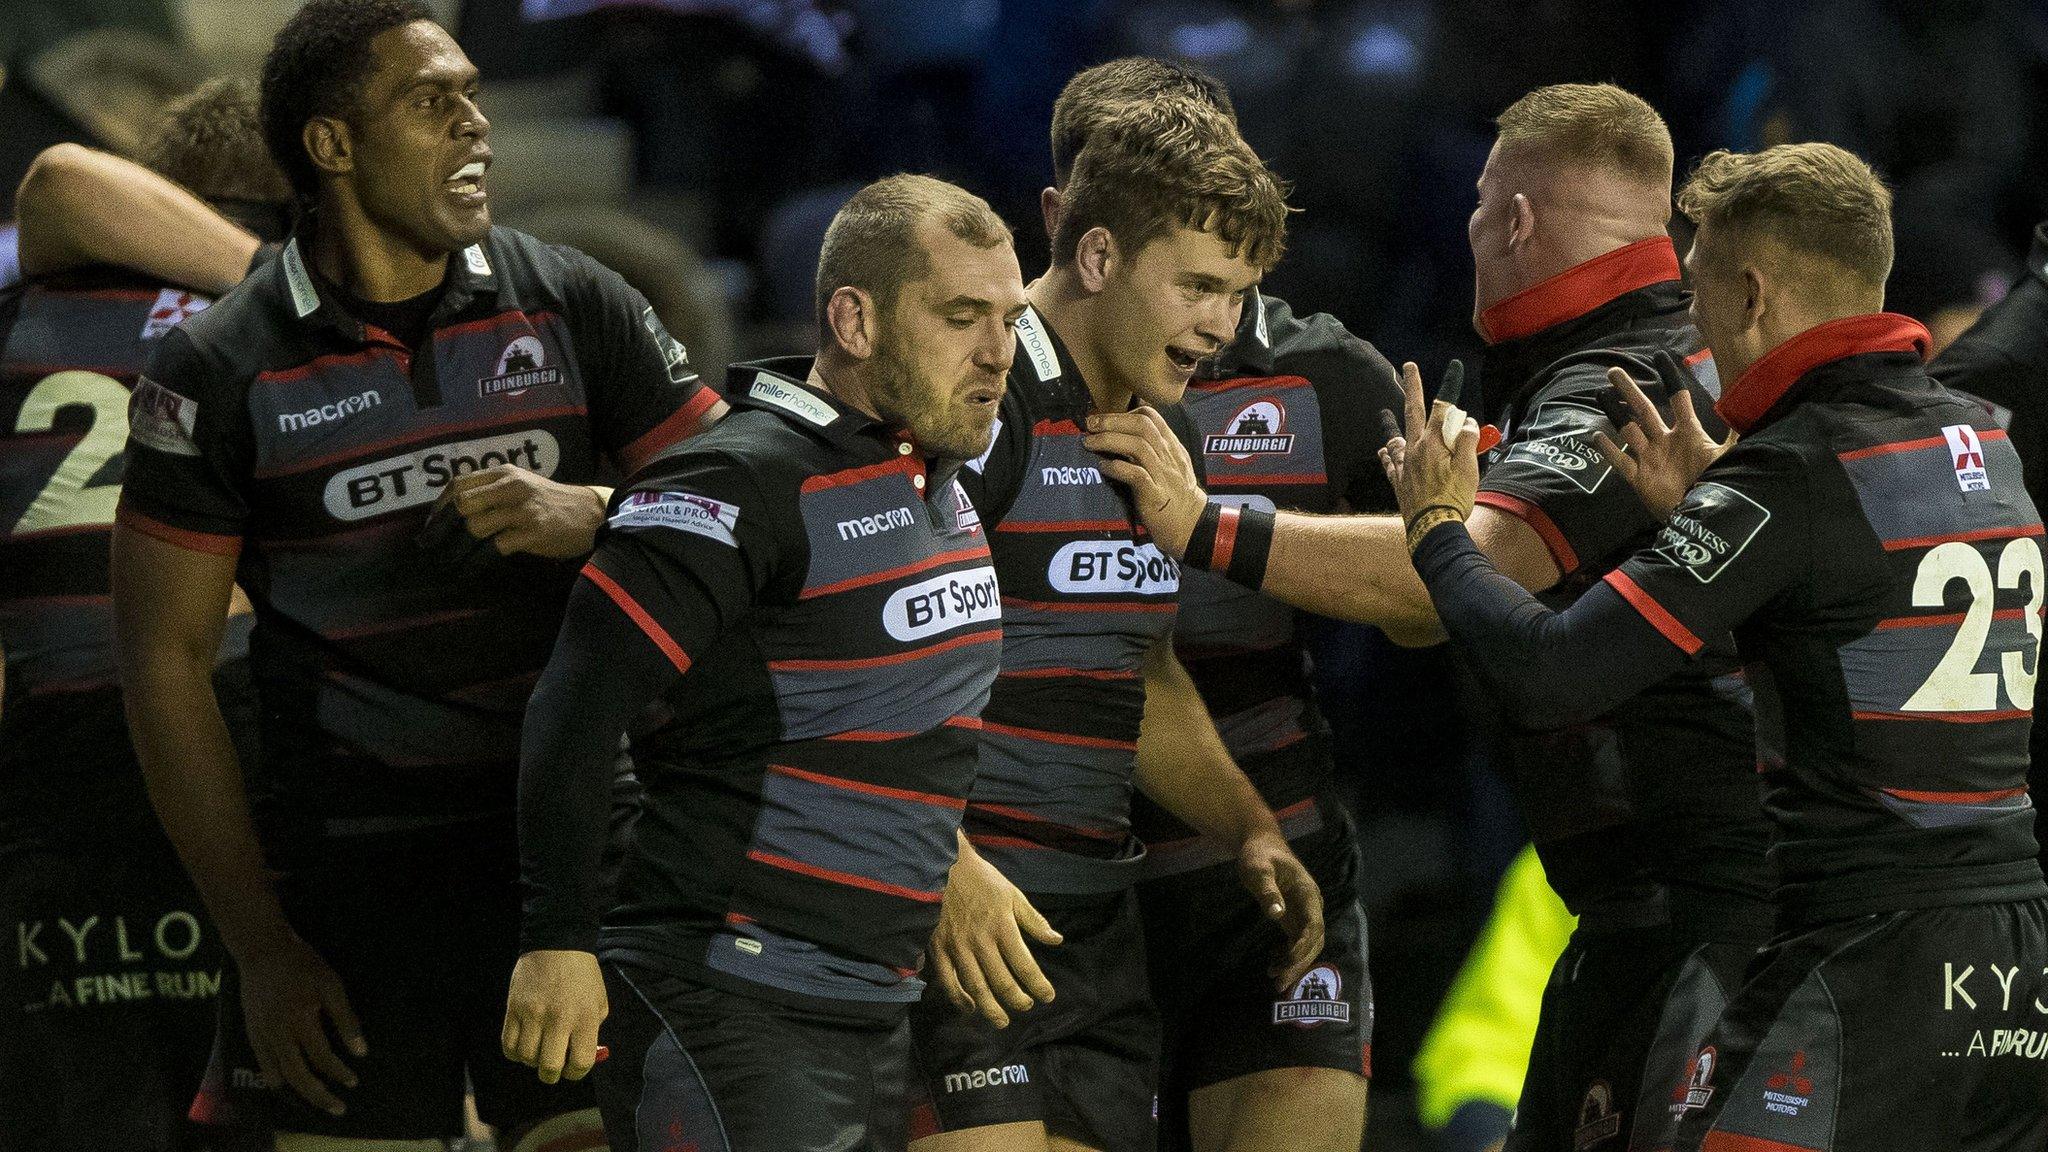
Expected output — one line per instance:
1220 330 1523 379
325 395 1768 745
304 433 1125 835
911 100 1323 1152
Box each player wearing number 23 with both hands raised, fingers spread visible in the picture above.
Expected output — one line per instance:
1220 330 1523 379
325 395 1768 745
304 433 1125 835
1384 143 2048 1152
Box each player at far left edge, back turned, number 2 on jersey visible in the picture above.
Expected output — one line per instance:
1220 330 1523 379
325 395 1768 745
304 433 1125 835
0 80 289 1152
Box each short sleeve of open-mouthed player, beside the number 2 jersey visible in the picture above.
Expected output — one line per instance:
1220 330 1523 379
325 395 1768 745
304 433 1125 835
119 328 256 556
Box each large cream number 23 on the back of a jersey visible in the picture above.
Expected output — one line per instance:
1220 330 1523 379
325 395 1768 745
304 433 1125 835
1905 537 2042 711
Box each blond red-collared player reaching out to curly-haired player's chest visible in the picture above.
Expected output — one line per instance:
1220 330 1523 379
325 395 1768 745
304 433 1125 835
1092 84 1772 1152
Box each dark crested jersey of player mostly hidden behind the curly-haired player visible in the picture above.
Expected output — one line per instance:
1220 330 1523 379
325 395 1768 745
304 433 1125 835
1133 293 1401 875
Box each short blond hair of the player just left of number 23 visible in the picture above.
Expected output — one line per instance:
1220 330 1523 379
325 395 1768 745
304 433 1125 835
1493 84 1671 184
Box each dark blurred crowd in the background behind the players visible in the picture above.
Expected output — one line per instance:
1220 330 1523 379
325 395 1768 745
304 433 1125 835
0 0 2048 1148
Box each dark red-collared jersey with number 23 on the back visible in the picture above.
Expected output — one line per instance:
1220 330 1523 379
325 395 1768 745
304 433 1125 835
1415 314 2048 927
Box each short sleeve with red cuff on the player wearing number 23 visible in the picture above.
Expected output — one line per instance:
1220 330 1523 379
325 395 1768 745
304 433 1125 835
1606 445 1812 654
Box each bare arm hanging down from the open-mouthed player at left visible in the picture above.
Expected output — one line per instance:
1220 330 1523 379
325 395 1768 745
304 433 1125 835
113 521 367 1115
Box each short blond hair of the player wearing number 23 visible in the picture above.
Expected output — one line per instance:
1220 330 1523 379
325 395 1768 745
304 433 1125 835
1677 143 1892 291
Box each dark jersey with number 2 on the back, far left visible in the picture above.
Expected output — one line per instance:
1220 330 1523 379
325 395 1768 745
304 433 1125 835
0 269 248 851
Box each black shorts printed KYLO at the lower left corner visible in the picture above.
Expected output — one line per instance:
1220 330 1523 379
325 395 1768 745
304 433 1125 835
0 840 223 1152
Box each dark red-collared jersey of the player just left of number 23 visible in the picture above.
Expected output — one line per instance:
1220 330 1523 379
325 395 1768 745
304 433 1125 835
1479 236 1772 914
